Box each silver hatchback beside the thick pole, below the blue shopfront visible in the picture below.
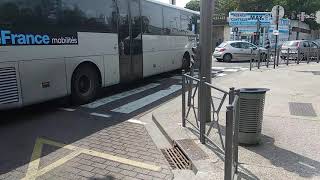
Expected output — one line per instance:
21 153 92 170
213 41 267 62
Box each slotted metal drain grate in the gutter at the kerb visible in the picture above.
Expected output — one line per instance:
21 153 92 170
161 146 191 169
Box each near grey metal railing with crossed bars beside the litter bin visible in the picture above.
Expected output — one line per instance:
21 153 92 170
182 70 239 180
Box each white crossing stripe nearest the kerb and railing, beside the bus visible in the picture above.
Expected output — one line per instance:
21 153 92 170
112 85 182 114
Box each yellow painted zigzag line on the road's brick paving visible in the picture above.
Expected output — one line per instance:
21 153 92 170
22 138 161 180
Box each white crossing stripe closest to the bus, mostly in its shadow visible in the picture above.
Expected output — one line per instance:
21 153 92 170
82 83 160 109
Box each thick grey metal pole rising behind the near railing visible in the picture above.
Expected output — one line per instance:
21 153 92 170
199 0 214 122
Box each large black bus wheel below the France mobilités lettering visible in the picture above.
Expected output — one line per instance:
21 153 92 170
71 65 100 104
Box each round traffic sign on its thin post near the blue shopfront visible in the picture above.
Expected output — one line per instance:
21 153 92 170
272 5 284 69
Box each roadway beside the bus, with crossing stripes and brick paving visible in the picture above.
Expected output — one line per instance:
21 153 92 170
0 61 247 179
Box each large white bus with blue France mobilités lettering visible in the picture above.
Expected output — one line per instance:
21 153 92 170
0 0 199 109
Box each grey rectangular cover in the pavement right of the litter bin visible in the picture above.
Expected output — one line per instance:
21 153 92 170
289 102 317 117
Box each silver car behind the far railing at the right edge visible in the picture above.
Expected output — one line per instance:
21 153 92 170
280 40 320 60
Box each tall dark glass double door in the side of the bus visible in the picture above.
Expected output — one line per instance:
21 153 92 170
118 0 143 82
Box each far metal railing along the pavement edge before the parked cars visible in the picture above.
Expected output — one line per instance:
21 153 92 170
250 48 320 70
